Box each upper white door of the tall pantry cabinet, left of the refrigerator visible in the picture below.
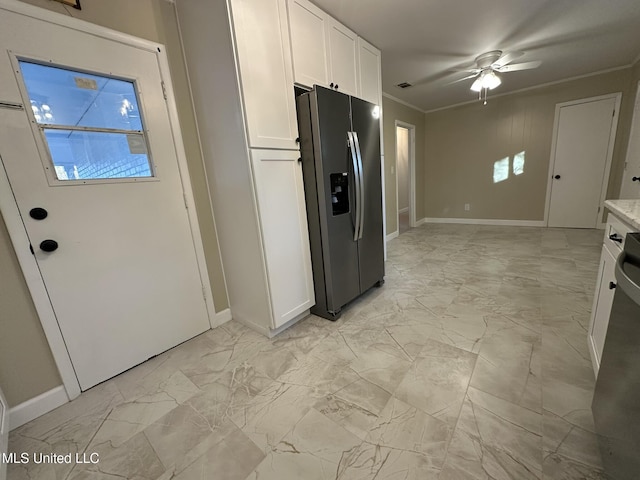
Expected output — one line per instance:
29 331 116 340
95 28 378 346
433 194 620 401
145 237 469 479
231 0 298 149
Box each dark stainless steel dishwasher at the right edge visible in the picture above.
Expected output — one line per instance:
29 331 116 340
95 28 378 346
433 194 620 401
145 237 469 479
591 233 640 480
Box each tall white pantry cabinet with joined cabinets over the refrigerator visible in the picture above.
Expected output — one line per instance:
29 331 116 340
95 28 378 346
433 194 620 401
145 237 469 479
175 0 382 336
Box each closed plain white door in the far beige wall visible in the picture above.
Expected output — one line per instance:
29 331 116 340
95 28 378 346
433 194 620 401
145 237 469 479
549 96 619 228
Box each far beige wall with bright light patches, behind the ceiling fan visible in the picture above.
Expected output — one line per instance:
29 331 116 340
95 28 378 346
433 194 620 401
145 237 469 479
424 68 633 220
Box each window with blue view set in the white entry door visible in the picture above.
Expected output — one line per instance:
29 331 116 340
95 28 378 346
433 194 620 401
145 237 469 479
19 60 153 181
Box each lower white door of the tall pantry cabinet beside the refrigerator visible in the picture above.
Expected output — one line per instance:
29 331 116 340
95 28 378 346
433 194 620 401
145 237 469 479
251 150 315 328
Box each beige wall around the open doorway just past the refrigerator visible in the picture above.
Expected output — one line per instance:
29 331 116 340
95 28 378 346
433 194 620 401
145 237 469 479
382 97 425 235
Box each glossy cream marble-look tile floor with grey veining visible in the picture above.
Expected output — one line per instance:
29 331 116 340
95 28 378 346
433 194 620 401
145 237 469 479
9 224 604 480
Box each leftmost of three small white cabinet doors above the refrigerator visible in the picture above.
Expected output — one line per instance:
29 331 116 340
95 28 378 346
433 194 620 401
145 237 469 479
288 0 329 88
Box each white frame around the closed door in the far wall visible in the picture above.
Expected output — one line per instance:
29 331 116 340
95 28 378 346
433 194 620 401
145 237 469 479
543 92 622 228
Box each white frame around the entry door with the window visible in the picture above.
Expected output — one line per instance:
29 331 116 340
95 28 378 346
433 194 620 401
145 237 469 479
0 0 216 400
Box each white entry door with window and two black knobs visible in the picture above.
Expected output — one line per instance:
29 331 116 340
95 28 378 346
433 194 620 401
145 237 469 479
0 7 209 390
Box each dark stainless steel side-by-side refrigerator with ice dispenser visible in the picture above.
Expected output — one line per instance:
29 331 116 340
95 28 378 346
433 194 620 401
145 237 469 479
297 85 384 320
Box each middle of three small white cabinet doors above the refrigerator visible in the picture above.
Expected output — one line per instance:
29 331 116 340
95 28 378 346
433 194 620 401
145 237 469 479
327 17 360 97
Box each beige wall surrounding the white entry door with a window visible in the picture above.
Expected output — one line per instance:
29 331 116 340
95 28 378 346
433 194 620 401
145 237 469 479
0 0 228 406
